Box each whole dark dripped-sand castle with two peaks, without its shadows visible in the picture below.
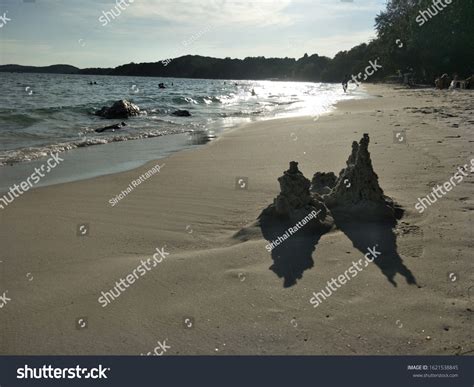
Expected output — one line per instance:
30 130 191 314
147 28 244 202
259 134 396 226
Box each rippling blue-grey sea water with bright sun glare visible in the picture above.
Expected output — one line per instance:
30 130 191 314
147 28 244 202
0 73 366 165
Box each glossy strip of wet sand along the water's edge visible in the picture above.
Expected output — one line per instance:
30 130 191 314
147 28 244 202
0 88 374 193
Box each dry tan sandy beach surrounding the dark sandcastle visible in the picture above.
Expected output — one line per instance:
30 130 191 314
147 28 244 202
0 85 474 355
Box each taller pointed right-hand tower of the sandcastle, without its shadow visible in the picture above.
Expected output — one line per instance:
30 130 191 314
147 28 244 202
324 134 395 218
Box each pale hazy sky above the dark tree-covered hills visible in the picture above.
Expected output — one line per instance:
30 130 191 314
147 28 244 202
0 0 386 68
